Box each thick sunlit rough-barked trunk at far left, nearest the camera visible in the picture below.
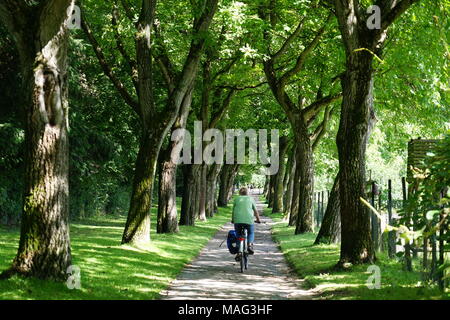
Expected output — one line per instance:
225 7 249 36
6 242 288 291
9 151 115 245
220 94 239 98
0 0 73 280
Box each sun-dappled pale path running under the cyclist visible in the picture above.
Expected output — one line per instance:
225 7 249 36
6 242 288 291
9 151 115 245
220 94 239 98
161 195 313 300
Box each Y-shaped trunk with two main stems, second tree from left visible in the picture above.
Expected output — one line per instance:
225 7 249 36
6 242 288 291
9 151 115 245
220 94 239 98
119 0 218 243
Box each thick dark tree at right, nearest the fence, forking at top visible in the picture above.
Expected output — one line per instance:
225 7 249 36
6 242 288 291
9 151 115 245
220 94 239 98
334 0 418 266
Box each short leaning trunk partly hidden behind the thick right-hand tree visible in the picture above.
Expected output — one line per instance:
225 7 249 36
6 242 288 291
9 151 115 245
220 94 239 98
314 173 341 244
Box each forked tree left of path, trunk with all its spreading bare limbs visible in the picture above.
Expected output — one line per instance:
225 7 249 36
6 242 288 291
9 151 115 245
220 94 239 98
82 0 218 243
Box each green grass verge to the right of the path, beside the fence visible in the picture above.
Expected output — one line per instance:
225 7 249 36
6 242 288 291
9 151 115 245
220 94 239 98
265 209 449 300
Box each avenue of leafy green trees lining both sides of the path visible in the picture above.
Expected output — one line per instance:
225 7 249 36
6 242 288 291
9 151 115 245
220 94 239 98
0 0 450 280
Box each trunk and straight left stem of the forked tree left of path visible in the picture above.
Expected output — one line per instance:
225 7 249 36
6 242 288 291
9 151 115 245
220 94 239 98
122 1 158 244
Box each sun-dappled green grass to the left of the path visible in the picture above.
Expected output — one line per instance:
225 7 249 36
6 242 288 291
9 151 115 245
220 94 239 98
0 200 231 299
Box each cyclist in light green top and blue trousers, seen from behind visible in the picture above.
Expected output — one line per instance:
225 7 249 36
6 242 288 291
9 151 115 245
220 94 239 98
231 187 261 259
